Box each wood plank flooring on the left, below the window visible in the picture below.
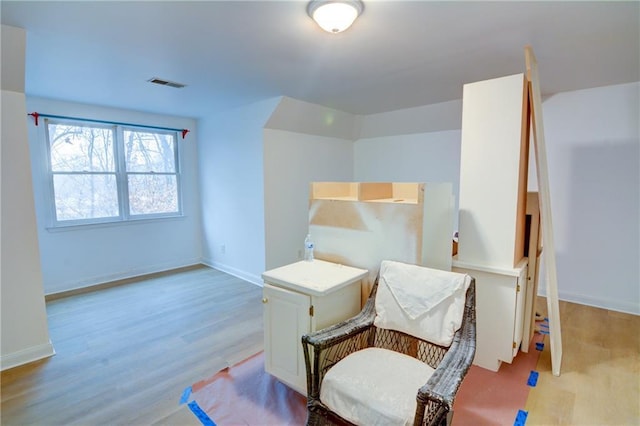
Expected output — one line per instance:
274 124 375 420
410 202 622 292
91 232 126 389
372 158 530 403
0 267 263 426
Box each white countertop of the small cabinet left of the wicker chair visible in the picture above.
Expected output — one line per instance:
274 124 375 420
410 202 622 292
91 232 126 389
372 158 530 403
262 259 369 296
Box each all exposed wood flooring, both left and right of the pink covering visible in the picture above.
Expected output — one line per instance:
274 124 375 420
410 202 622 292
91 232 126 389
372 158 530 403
0 268 640 426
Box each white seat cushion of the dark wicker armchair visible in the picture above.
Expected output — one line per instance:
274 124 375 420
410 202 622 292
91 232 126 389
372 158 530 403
320 348 434 426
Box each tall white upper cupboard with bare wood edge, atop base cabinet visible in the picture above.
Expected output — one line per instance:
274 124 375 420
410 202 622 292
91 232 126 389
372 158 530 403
458 74 528 268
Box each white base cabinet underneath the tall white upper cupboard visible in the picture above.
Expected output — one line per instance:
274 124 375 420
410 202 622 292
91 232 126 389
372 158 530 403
453 258 529 371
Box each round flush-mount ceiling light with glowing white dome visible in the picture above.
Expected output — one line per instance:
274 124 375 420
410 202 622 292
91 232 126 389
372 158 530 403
307 0 364 34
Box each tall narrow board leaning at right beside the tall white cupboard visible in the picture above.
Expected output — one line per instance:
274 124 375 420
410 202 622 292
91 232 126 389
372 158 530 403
524 46 562 376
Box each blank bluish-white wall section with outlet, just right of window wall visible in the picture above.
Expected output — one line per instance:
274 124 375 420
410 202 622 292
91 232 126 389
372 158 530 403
198 98 284 284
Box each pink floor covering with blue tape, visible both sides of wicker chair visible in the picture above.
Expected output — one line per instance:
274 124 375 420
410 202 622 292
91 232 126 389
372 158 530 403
182 334 544 426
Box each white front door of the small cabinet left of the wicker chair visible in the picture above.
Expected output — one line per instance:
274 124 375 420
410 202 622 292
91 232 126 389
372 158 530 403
263 283 311 394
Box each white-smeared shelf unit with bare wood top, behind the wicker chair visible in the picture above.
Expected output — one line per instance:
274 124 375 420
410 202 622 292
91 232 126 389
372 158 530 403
309 182 453 302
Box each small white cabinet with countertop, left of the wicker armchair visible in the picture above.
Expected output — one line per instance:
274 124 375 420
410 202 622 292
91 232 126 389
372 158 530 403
262 259 368 395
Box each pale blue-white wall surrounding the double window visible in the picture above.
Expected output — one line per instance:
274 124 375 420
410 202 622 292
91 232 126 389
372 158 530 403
27 97 202 294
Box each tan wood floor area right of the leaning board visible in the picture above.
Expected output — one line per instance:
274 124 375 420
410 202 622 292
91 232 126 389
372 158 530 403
525 298 640 426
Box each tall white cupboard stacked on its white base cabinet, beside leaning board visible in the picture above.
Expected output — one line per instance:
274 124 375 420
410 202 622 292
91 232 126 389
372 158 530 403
453 74 529 371
